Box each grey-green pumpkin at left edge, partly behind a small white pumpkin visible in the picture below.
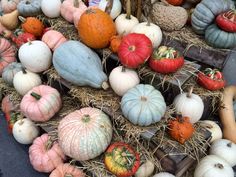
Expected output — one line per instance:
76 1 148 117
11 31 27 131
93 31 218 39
2 62 22 86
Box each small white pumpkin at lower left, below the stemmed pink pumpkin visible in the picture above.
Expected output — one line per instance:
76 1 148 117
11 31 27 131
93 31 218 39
12 118 39 144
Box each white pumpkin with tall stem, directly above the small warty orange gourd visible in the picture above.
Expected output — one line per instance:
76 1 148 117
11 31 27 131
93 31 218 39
173 87 204 123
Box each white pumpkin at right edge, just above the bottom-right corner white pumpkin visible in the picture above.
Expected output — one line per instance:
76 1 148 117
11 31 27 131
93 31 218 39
210 139 236 167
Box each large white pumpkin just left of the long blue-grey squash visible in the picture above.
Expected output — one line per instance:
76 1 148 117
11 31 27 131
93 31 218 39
18 40 52 73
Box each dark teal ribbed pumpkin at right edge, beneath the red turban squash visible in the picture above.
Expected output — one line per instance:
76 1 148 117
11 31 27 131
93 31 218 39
205 24 236 49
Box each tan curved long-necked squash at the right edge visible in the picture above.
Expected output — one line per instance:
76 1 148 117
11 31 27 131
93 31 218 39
219 86 236 143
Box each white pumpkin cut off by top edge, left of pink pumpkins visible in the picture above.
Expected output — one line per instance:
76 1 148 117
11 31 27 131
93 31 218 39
41 0 61 18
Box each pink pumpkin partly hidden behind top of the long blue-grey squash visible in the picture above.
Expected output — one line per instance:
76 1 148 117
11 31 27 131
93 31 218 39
42 30 67 51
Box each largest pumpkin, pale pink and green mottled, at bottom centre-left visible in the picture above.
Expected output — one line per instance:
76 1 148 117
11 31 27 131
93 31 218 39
58 107 112 161
